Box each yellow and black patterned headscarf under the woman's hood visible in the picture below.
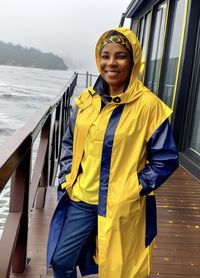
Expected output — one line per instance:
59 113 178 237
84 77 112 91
101 31 132 53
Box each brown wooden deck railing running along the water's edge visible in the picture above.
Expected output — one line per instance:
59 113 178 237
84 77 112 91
0 73 78 278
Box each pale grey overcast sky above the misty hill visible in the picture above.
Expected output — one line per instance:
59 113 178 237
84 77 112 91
0 0 131 72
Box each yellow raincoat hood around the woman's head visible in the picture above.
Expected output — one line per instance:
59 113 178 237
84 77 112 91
96 28 142 102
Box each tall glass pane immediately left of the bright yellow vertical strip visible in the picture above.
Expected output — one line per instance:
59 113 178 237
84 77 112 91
161 0 185 106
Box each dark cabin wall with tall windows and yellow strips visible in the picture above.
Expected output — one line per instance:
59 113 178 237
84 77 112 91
122 0 200 178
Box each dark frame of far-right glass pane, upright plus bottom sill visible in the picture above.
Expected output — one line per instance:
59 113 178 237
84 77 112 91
176 0 200 179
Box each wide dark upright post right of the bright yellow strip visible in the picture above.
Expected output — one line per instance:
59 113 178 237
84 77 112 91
171 0 200 148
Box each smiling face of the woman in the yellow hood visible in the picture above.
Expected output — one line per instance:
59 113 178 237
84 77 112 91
100 43 132 95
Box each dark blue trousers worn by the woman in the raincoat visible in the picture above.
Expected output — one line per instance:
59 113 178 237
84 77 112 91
51 201 98 278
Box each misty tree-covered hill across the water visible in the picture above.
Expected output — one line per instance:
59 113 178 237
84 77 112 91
0 41 68 70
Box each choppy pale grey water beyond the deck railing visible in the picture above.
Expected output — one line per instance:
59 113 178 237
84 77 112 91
0 66 84 238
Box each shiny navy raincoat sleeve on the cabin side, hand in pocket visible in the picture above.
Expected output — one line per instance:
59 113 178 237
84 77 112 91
138 120 179 196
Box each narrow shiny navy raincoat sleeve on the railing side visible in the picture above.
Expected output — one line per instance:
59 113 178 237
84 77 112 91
58 107 78 197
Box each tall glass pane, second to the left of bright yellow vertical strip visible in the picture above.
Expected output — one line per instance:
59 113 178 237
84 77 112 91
145 1 167 94
